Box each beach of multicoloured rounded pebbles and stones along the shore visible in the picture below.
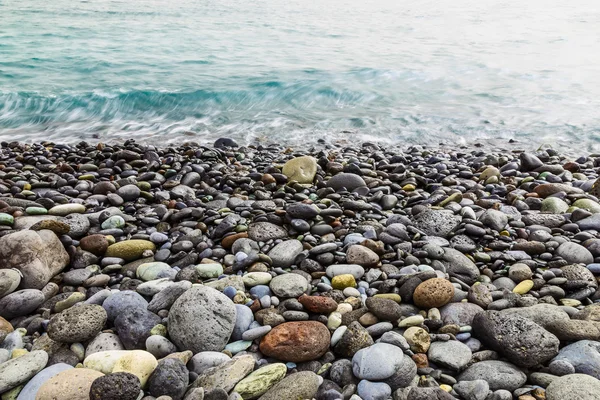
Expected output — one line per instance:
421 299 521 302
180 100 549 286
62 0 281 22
0 139 600 400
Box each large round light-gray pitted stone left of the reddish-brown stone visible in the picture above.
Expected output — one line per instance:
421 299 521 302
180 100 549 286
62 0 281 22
169 286 236 353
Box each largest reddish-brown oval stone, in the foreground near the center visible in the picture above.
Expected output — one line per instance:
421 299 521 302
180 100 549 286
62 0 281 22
260 321 331 362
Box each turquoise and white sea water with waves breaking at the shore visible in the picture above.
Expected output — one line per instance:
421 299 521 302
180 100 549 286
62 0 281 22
0 0 600 149
